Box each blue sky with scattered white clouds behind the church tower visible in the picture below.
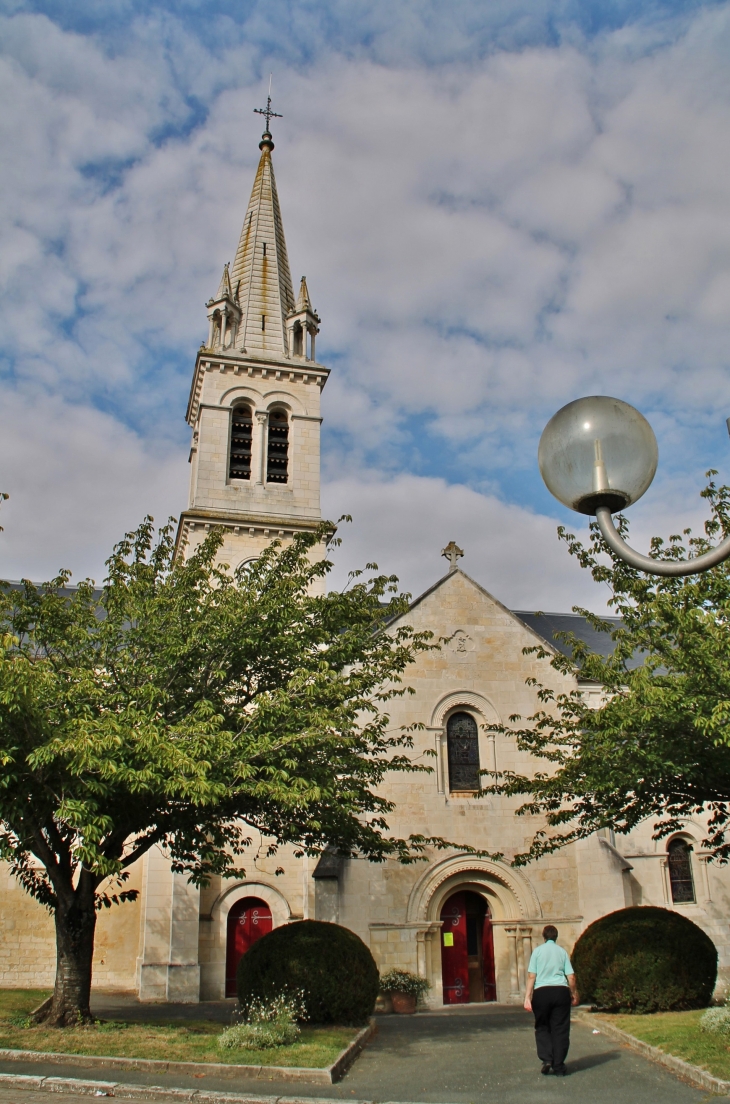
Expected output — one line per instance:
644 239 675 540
0 0 730 611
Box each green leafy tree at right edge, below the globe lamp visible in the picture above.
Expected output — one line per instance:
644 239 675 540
487 471 730 864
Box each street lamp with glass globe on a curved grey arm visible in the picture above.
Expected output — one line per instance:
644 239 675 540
538 395 730 575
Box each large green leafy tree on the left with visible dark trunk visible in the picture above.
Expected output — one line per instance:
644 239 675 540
0 519 441 1026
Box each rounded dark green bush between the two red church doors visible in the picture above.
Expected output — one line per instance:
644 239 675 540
236 920 379 1023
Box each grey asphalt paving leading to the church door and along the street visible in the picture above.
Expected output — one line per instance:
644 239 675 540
0 998 717 1104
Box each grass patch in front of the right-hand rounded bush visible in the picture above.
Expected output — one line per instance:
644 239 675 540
595 1009 730 1081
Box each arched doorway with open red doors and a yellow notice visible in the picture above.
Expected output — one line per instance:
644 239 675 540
441 890 497 1005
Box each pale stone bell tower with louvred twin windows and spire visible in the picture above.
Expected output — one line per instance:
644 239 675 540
177 116 329 569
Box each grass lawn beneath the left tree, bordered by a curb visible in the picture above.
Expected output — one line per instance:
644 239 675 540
0 989 359 1069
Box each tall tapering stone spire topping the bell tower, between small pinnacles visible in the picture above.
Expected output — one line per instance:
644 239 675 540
230 130 294 357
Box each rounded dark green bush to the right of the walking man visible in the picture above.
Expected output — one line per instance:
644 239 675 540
572 906 718 1012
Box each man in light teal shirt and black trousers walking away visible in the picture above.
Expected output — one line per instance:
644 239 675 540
525 924 578 1078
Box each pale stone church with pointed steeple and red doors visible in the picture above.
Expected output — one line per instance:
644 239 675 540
0 120 730 1008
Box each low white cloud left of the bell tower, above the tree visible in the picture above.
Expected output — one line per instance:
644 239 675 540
0 394 188 583
